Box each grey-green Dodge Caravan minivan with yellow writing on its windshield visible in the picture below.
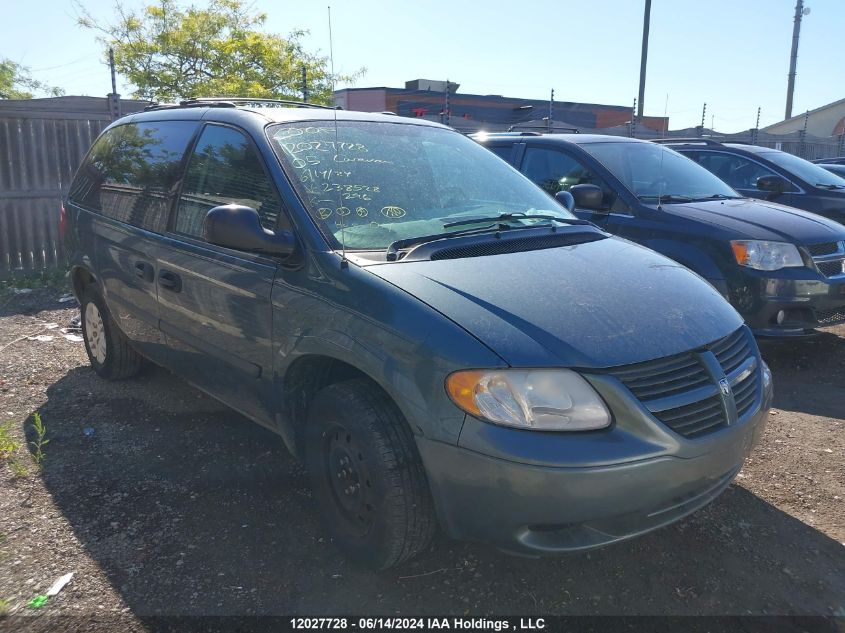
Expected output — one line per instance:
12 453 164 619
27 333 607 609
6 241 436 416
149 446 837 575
67 99 772 568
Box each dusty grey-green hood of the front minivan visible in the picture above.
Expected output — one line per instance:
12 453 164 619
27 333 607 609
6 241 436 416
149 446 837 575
367 238 742 368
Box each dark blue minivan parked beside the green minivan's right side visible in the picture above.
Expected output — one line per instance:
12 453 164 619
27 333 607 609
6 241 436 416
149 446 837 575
476 134 845 336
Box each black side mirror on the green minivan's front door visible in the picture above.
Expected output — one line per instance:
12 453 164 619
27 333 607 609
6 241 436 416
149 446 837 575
205 204 296 255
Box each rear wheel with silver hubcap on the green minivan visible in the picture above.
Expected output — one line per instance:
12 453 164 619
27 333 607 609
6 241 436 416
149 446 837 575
79 286 144 380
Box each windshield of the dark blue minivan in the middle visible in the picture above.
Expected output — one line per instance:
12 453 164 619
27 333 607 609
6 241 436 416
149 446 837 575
581 142 739 202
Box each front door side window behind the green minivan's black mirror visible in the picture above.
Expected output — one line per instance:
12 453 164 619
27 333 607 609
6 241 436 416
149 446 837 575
176 125 281 238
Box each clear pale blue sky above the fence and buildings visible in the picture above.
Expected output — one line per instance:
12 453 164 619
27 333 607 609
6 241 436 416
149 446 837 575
0 0 845 132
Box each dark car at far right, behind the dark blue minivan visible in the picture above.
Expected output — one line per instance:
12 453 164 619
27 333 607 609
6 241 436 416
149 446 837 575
656 139 845 224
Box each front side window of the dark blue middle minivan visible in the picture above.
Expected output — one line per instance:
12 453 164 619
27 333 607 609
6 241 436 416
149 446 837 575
522 147 625 211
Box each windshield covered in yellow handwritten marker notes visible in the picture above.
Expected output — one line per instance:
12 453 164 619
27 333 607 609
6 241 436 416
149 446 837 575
268 121 574 250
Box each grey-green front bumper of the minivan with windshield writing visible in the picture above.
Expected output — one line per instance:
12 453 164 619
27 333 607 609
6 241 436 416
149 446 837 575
417 392 771 555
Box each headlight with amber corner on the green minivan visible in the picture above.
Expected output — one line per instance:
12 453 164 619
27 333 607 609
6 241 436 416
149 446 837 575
446 369 610 431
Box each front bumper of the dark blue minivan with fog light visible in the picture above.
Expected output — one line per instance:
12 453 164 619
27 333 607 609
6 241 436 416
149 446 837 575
730 269 845 337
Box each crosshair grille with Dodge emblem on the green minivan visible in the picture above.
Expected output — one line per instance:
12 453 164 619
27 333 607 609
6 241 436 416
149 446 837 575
610 326 760 438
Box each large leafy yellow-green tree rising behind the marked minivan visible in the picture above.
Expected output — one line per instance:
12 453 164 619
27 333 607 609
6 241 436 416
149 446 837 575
76 0 364 103
